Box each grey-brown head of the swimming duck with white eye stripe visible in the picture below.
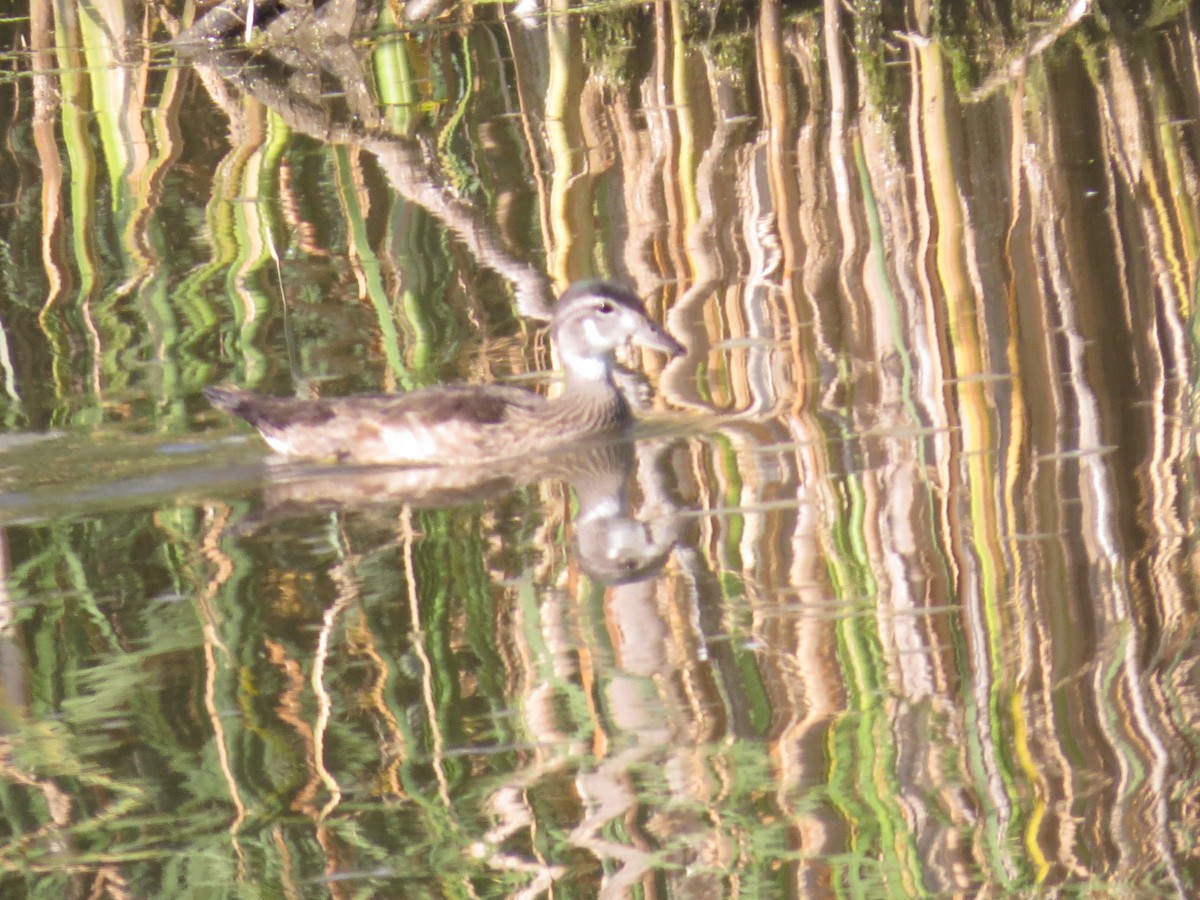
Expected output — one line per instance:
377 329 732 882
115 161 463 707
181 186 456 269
551 281 684 378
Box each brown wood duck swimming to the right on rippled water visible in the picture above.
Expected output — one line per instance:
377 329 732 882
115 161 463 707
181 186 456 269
204 281 683 466
